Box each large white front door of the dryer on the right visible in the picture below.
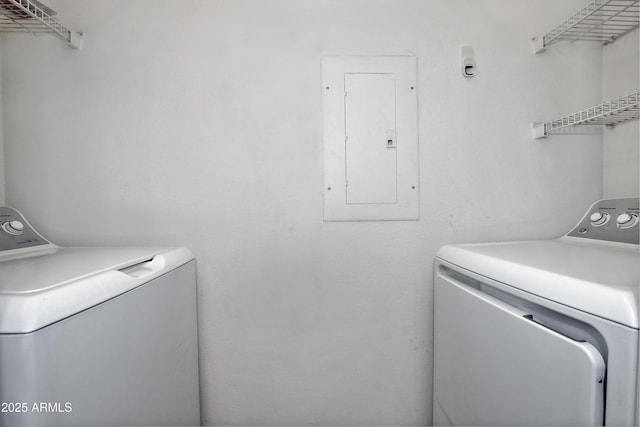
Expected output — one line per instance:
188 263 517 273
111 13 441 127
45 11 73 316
434 268 605 426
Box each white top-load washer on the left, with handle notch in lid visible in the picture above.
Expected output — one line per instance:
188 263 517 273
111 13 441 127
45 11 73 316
0 207 200 426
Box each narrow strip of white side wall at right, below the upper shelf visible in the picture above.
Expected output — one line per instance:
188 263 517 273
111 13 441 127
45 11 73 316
602 29 640 198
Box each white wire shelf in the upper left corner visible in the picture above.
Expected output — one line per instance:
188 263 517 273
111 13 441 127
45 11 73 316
0 0 82 49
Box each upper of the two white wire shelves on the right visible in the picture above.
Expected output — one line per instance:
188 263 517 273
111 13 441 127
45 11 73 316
533 0 640 53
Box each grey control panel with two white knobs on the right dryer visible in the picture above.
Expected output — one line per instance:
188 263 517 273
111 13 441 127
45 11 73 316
567 198 640 245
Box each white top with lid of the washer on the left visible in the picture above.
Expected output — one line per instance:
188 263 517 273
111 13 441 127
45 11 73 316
0 247 193 334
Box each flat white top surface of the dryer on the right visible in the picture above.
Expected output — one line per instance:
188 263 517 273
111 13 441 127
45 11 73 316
436 239 640 328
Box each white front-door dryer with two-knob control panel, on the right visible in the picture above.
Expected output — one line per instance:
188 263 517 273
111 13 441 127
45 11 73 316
433 198 640 426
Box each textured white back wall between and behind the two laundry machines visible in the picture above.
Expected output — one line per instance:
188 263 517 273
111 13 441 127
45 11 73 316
1 0 602 425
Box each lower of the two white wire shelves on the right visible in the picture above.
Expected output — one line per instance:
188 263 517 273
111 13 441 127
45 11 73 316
533 91 640 138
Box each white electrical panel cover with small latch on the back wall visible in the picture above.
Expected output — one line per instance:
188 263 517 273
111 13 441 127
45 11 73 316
322 56 420 221
